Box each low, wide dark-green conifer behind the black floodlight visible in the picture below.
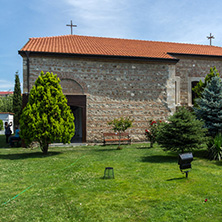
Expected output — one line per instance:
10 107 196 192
157 107 207 153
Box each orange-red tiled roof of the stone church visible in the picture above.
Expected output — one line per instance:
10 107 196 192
20 35 222 59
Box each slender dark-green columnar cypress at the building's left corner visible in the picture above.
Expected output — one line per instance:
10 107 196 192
13 72 22 126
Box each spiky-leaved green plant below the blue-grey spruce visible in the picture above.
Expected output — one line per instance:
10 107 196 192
208 133 222 160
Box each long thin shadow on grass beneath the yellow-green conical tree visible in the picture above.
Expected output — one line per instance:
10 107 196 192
0 152 61 160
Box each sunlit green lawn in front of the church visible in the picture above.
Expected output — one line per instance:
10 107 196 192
0 136 222 222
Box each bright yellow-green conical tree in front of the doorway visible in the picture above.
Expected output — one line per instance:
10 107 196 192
20 72 75 154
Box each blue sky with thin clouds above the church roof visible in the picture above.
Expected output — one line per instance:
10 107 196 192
0 0 222 91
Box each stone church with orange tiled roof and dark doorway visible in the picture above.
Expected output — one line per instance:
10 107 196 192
19 35 222 142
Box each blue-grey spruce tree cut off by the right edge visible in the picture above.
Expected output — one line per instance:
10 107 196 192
194 76 222 137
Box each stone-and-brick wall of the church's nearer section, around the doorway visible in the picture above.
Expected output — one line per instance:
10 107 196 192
23 56 175 142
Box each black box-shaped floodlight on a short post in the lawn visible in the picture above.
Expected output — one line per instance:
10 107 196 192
178 153 193 178
